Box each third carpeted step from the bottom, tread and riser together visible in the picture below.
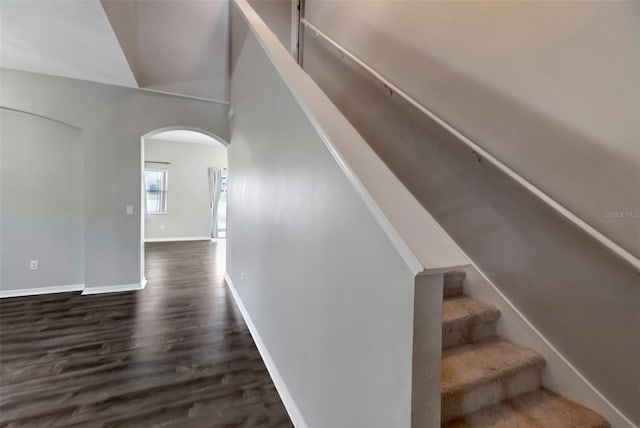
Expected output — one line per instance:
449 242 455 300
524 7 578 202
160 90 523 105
442 295 500 349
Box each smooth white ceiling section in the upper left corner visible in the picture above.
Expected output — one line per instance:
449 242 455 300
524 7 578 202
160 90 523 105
0 0 137 87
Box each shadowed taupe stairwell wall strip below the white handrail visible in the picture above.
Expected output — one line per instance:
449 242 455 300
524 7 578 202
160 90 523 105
304 33 640 423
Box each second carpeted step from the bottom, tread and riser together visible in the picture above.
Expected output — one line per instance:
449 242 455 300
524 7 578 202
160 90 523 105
441 337 544 422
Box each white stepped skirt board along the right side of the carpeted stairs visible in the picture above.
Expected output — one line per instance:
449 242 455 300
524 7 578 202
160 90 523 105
464 265 637 428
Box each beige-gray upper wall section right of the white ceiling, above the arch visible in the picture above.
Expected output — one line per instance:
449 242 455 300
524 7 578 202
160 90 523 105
101 0 229 100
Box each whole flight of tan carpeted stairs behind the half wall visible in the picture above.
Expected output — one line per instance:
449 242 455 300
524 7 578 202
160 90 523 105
441 272 609 428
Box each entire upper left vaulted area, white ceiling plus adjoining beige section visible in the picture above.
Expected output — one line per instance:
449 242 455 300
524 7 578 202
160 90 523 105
0 0 229 100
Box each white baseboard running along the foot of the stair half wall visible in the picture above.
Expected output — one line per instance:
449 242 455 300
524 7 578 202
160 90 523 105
224 272 308 428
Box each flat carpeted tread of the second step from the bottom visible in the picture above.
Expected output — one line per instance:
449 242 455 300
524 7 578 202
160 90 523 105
441 336 545 398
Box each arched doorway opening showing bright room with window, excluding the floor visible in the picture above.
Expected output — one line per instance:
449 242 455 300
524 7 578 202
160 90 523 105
140 127 228 282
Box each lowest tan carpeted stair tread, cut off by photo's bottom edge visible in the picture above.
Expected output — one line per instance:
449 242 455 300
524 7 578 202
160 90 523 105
443 389 609 428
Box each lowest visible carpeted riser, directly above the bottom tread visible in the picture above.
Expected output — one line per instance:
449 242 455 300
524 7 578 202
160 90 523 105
441 366 542 422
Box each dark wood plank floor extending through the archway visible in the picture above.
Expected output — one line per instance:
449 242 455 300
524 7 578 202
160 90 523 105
0 241 291 428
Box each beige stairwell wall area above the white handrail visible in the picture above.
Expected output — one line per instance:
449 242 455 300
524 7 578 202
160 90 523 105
306 0 640 257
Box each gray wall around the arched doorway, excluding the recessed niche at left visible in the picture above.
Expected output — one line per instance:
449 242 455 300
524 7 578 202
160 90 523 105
0 69 228 287
